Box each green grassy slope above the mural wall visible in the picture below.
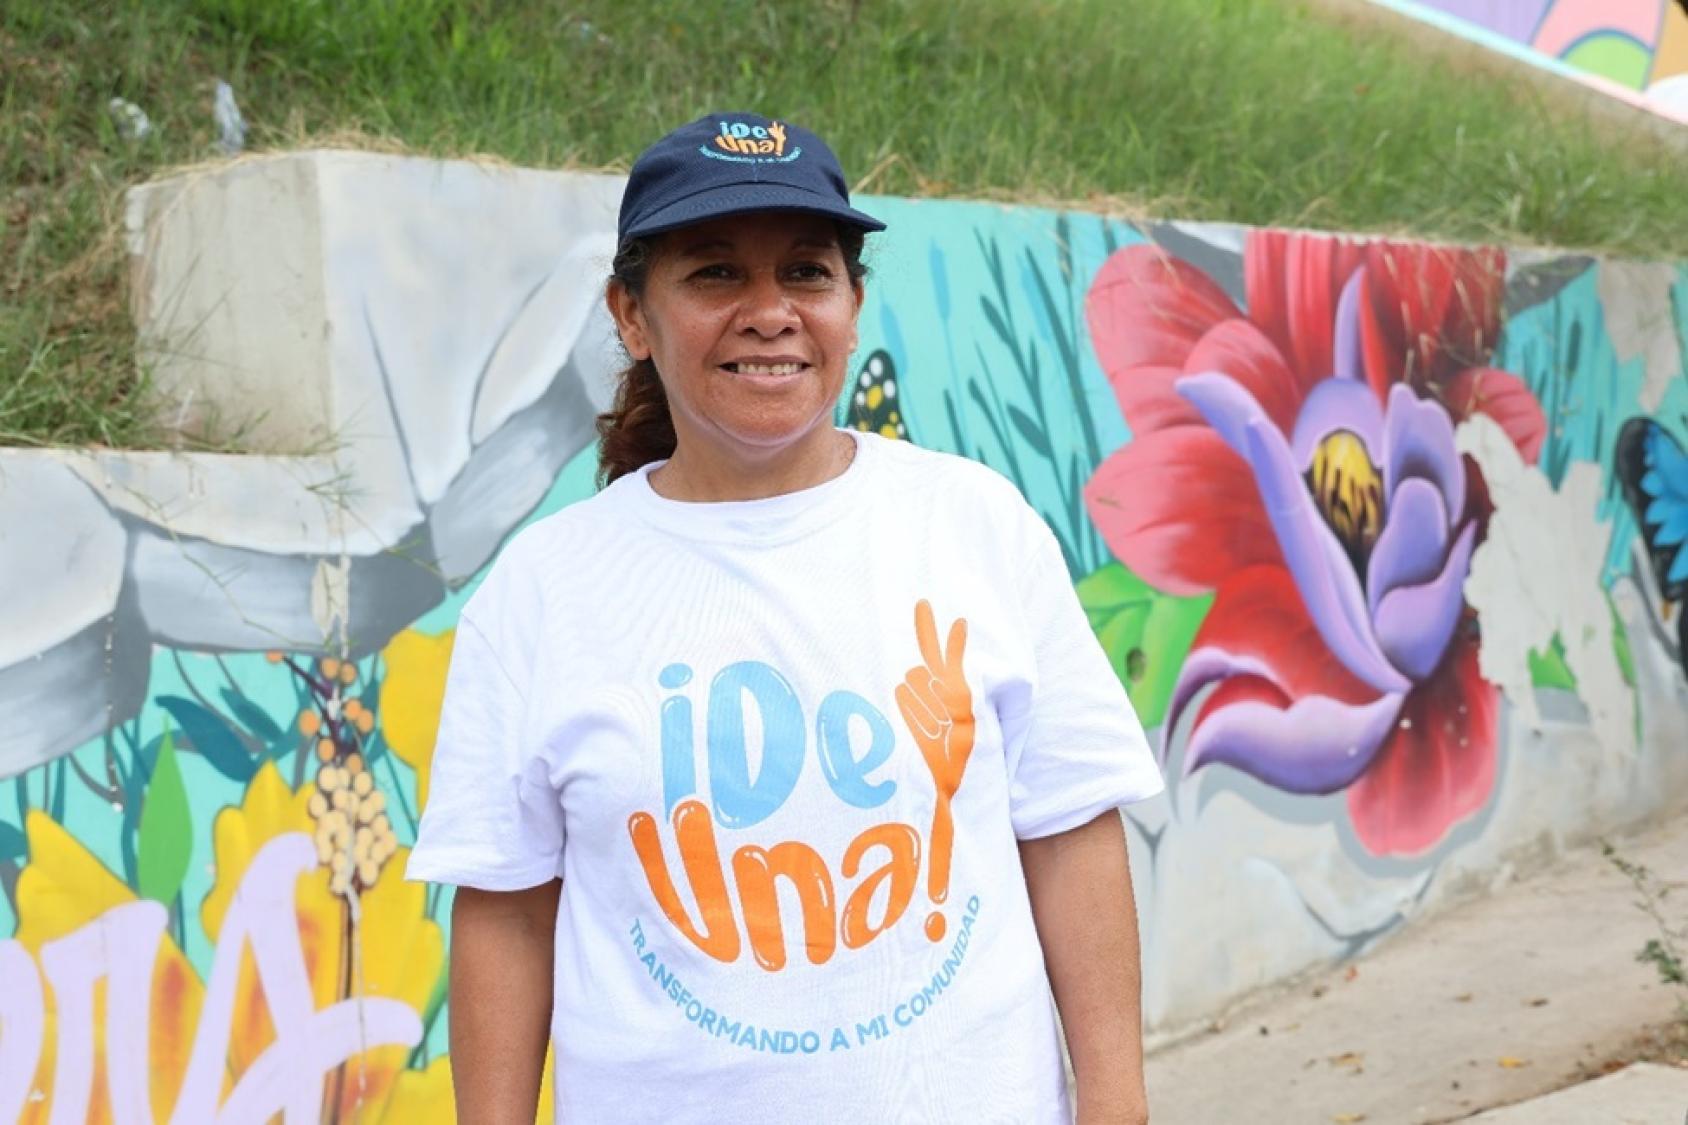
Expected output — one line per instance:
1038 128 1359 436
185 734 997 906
0 0 1688 446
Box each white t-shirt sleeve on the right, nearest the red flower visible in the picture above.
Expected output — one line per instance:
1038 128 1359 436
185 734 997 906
1001 515 1165 840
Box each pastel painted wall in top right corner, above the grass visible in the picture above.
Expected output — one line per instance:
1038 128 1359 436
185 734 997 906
1372 0 1688 123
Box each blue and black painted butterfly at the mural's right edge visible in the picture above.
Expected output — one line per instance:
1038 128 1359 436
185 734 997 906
1612 417 1688 671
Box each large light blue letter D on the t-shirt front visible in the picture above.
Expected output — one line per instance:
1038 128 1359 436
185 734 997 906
709 660 805 828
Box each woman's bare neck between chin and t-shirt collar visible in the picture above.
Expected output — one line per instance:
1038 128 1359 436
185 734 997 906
650 426 856 503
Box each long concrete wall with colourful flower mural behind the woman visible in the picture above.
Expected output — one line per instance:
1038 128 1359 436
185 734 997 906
0 154 1688 1122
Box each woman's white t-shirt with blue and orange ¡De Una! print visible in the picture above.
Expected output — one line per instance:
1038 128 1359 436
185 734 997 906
408 431 1161 1125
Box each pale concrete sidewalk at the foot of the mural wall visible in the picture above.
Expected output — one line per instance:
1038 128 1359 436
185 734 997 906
1148 818 1688 1125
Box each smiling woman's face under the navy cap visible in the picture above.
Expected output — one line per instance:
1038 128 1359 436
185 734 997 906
609 211 863 461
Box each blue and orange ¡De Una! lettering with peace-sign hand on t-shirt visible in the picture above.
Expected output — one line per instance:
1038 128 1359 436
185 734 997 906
628 600 974 973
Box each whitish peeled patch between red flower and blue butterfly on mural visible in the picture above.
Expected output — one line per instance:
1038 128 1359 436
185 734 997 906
1455 414 1636 757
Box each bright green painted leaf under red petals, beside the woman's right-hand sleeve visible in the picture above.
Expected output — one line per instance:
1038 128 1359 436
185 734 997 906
1075 563 1214 726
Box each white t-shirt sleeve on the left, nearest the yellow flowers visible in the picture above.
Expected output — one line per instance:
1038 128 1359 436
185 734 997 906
405 552 564 890
